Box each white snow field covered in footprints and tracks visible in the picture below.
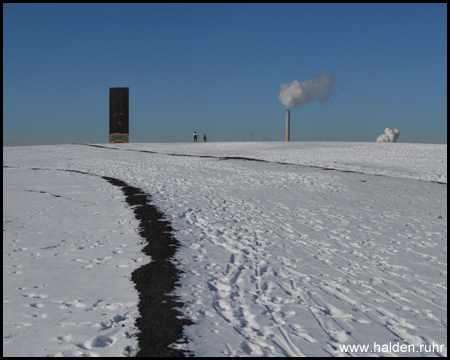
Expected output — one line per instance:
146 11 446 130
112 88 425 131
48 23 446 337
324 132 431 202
3 142 447 357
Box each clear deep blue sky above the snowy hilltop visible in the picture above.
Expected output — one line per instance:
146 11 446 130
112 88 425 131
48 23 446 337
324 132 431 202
3 4 447 146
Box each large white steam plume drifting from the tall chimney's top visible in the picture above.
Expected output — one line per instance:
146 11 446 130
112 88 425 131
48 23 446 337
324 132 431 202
278 72 335 109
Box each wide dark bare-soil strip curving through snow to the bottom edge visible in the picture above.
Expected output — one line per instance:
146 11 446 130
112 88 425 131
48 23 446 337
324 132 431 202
3 165 193 357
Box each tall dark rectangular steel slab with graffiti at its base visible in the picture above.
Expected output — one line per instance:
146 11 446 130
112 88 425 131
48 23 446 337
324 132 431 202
109 88 130 143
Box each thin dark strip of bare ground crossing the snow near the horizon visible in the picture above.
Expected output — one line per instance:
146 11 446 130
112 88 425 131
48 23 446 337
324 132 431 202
80 144 447 185
